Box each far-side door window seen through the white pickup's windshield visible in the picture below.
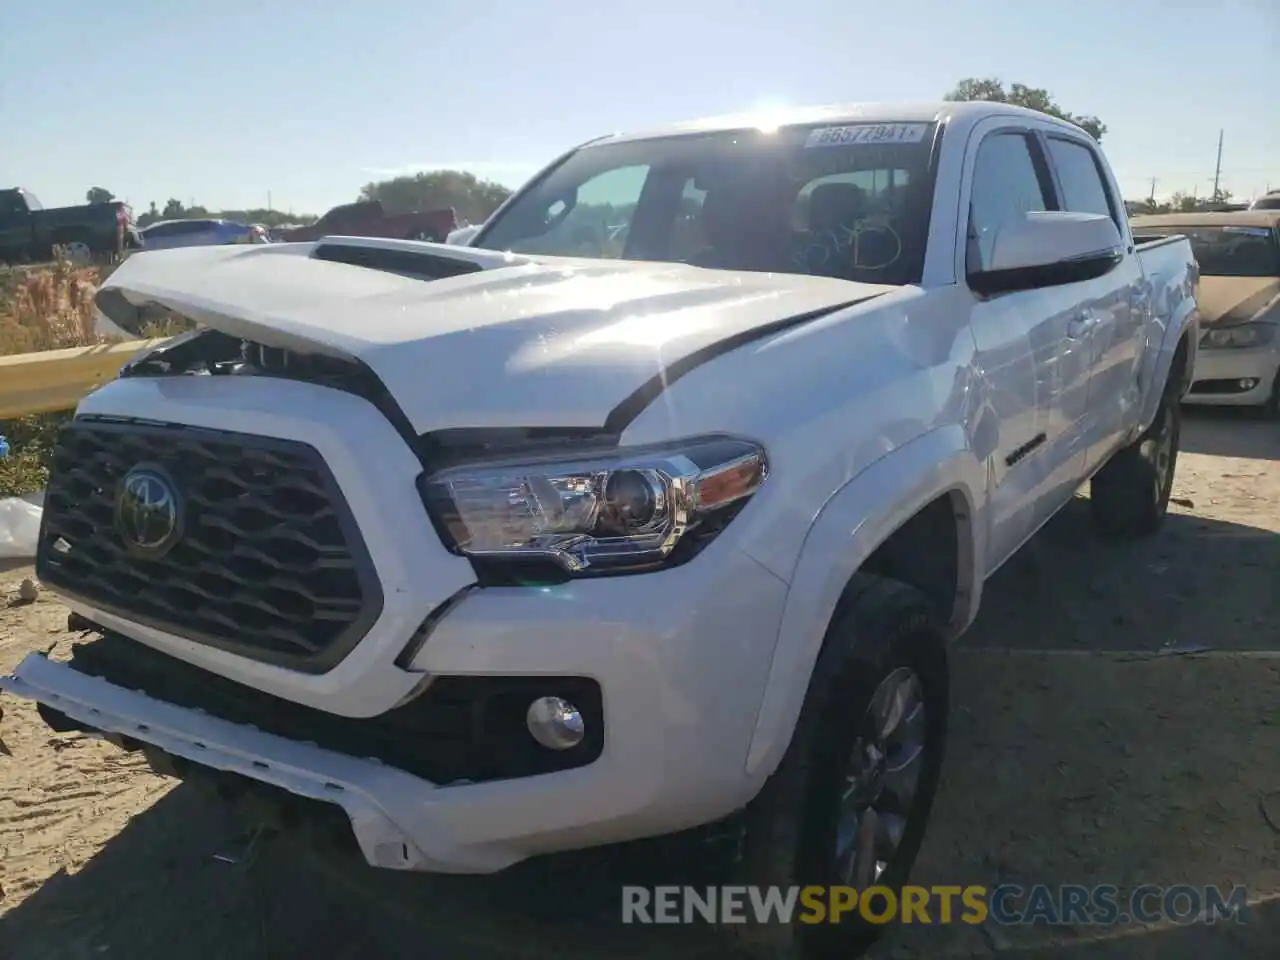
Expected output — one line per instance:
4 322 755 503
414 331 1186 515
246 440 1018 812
511 165 649 260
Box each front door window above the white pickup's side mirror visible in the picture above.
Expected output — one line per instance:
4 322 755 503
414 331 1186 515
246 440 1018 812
966 133 1052 271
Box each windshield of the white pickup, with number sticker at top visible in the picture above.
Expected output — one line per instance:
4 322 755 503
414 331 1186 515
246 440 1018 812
472 123 934 284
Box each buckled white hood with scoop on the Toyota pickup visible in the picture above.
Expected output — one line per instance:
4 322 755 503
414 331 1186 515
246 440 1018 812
97 238 899 433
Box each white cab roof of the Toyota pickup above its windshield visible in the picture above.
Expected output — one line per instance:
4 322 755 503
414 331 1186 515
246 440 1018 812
591 100 1082 145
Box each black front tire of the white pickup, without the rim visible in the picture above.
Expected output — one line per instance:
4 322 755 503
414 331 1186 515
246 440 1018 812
730 573 950 960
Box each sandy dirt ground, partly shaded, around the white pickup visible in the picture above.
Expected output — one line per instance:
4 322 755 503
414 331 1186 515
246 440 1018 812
0 413 1280 960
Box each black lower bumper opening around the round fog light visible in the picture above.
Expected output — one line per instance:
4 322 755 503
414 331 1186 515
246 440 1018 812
55 632 604 785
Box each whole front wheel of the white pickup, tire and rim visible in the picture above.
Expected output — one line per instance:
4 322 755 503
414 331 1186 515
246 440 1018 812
735 573 948 960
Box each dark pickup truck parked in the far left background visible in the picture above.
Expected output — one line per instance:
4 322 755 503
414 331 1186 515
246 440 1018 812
0 187 142 265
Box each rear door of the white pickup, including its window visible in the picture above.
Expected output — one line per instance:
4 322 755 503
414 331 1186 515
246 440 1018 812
1043 127 1149 470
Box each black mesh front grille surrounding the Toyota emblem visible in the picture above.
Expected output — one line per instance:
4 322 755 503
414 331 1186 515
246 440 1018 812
37 417 383 673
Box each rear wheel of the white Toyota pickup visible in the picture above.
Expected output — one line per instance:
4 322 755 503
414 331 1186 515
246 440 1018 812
1089 378 1183 540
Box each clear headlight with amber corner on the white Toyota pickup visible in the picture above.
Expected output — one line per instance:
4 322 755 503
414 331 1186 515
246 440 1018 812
424 438 768 573
